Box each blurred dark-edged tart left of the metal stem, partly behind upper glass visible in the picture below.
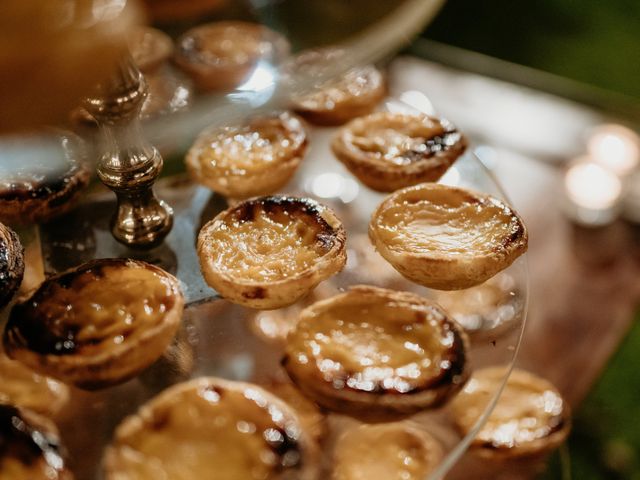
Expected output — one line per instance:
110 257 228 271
0 135 91 224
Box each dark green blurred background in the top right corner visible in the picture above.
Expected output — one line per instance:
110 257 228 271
423 0 640 98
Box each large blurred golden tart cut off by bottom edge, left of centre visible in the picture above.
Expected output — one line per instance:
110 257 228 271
104 378 318 480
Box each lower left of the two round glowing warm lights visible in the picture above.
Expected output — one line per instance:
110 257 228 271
564 161 622 210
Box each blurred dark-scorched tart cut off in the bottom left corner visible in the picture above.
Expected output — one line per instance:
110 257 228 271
0 405 73 480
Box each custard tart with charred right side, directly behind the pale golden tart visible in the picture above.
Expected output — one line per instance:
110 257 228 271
331 112 467 192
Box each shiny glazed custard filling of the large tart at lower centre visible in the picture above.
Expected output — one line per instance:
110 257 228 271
287 287 462 393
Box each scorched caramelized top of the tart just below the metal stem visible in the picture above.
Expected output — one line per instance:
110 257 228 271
4 259 181 357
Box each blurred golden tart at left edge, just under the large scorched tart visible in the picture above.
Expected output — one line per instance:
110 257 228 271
0 353 69 416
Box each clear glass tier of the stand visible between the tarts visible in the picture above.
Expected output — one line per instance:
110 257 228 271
31 128 528 479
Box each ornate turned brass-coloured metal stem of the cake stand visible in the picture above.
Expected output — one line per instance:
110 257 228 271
84 55 173 249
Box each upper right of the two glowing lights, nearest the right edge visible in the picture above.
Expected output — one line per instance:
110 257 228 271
587 125 640 175
